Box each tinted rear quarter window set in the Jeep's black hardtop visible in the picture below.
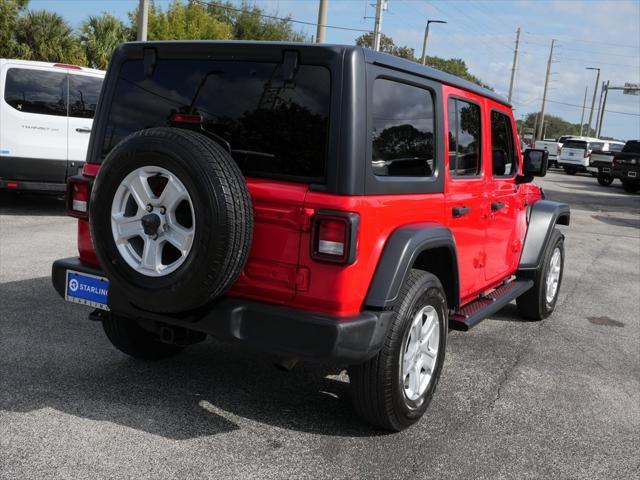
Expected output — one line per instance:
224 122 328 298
371 79 434 177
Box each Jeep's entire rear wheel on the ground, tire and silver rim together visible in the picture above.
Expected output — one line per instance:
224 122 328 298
349 270 448 431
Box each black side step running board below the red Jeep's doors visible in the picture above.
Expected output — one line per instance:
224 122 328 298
449 280 533 332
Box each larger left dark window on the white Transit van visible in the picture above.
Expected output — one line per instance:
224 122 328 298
4 68 67 116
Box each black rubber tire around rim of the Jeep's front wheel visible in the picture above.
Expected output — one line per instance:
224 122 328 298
516 228 564 320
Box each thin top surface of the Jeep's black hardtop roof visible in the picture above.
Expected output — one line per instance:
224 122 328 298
122 40 511 107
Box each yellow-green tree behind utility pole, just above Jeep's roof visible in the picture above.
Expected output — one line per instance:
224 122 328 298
129 0 232 40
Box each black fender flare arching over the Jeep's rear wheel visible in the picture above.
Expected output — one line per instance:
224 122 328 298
364 222 460 309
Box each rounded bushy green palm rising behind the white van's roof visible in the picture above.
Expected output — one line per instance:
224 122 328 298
15 10 86 65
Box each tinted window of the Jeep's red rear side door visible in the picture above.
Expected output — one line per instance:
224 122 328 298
448 98 482 177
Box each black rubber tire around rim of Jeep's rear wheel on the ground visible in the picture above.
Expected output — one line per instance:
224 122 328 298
349 270 448 431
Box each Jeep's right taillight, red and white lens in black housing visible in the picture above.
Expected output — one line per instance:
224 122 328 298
311 211 360 265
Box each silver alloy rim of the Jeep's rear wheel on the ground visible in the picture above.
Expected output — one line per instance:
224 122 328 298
400 305 440 401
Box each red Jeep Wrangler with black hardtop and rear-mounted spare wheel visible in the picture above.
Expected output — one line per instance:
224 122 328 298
52 42 570 430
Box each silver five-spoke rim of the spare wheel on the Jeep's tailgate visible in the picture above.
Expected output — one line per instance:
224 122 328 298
111 166 196 277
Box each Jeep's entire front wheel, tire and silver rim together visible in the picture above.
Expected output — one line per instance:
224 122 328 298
516 228 564 320
